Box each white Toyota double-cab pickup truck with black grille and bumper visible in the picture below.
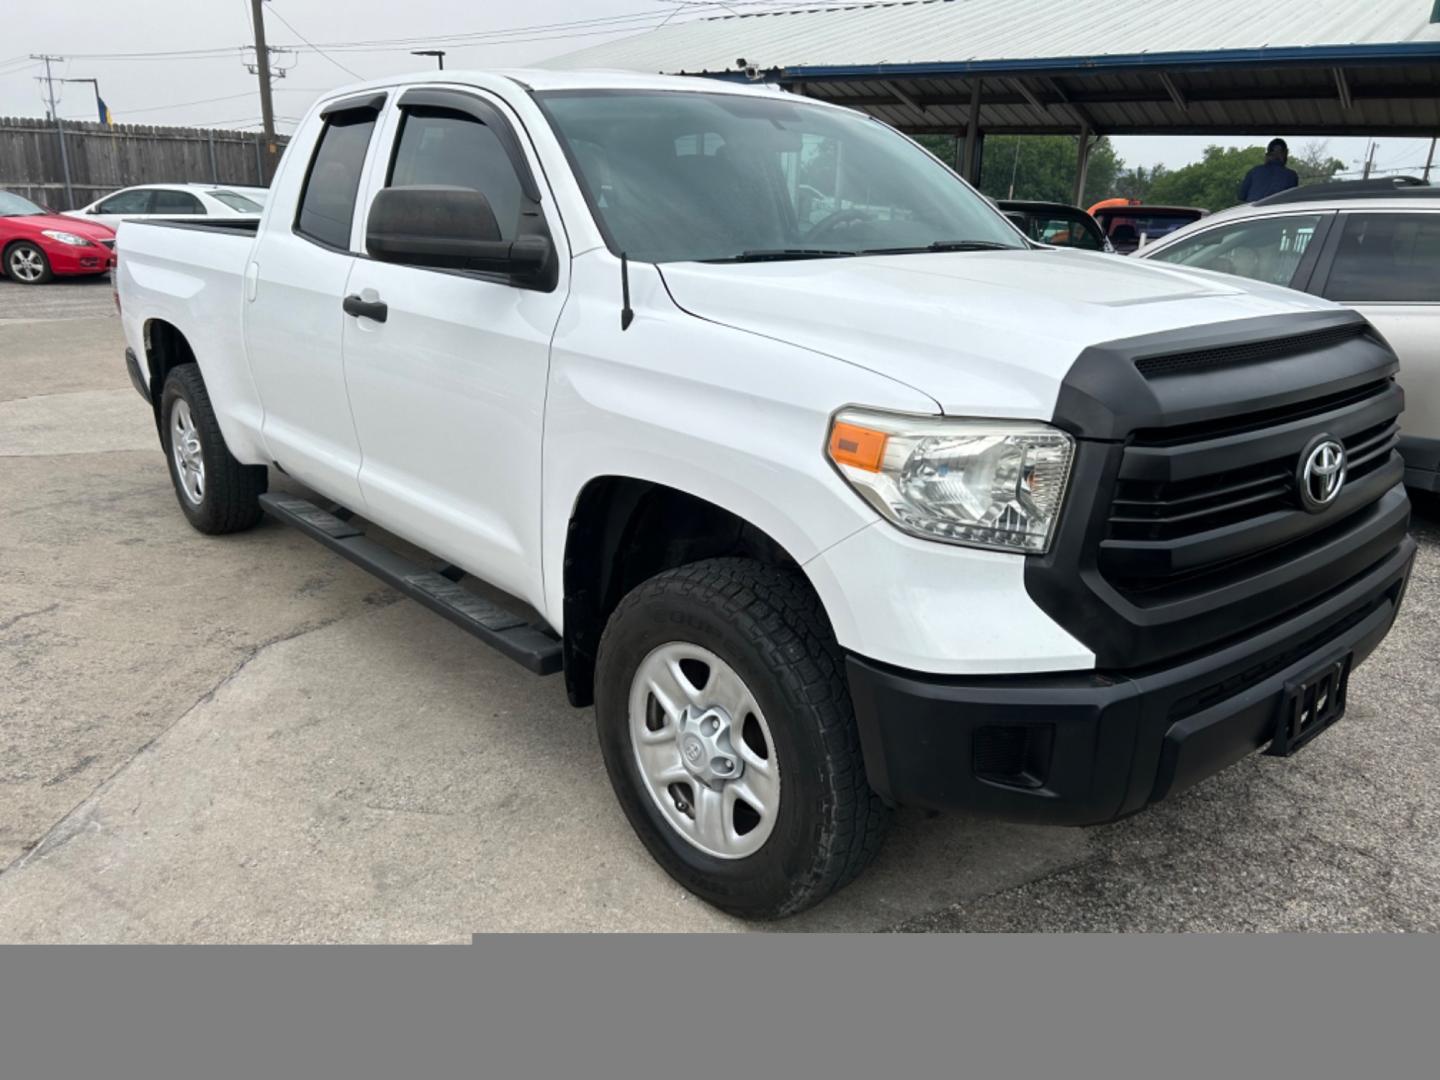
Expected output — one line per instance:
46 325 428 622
117 72 1414 917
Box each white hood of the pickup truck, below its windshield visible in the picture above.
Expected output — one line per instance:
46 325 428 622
660 249 1335 419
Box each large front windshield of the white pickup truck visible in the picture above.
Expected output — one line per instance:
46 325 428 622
539 91 1025 262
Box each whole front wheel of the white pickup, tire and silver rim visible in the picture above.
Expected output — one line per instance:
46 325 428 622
595 559 888 919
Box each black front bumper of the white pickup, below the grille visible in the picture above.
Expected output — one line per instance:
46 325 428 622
848 537 1416 825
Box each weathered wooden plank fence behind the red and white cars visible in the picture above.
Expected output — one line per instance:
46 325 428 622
0 117 285 210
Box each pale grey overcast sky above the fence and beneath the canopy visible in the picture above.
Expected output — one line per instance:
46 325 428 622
0 0 1430 179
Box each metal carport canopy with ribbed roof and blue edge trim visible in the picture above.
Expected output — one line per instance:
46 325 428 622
547 0 1440 144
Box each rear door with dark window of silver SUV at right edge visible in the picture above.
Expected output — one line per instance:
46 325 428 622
1310 209 1440 469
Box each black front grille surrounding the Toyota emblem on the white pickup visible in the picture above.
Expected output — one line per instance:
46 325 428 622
1025 310 1410 671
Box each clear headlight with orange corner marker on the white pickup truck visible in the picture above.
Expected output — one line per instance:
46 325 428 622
829 409 1074 554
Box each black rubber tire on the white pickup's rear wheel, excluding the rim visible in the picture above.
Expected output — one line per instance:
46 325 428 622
160 364 269 536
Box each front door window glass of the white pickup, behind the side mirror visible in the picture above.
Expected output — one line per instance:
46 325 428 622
387 108 521 240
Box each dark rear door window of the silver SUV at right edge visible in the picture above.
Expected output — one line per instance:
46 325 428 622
1323 213 1440 304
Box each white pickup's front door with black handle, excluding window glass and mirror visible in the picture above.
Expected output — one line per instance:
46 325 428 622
344 88 569 603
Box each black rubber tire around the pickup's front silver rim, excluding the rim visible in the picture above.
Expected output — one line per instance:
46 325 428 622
595 559 890 919
